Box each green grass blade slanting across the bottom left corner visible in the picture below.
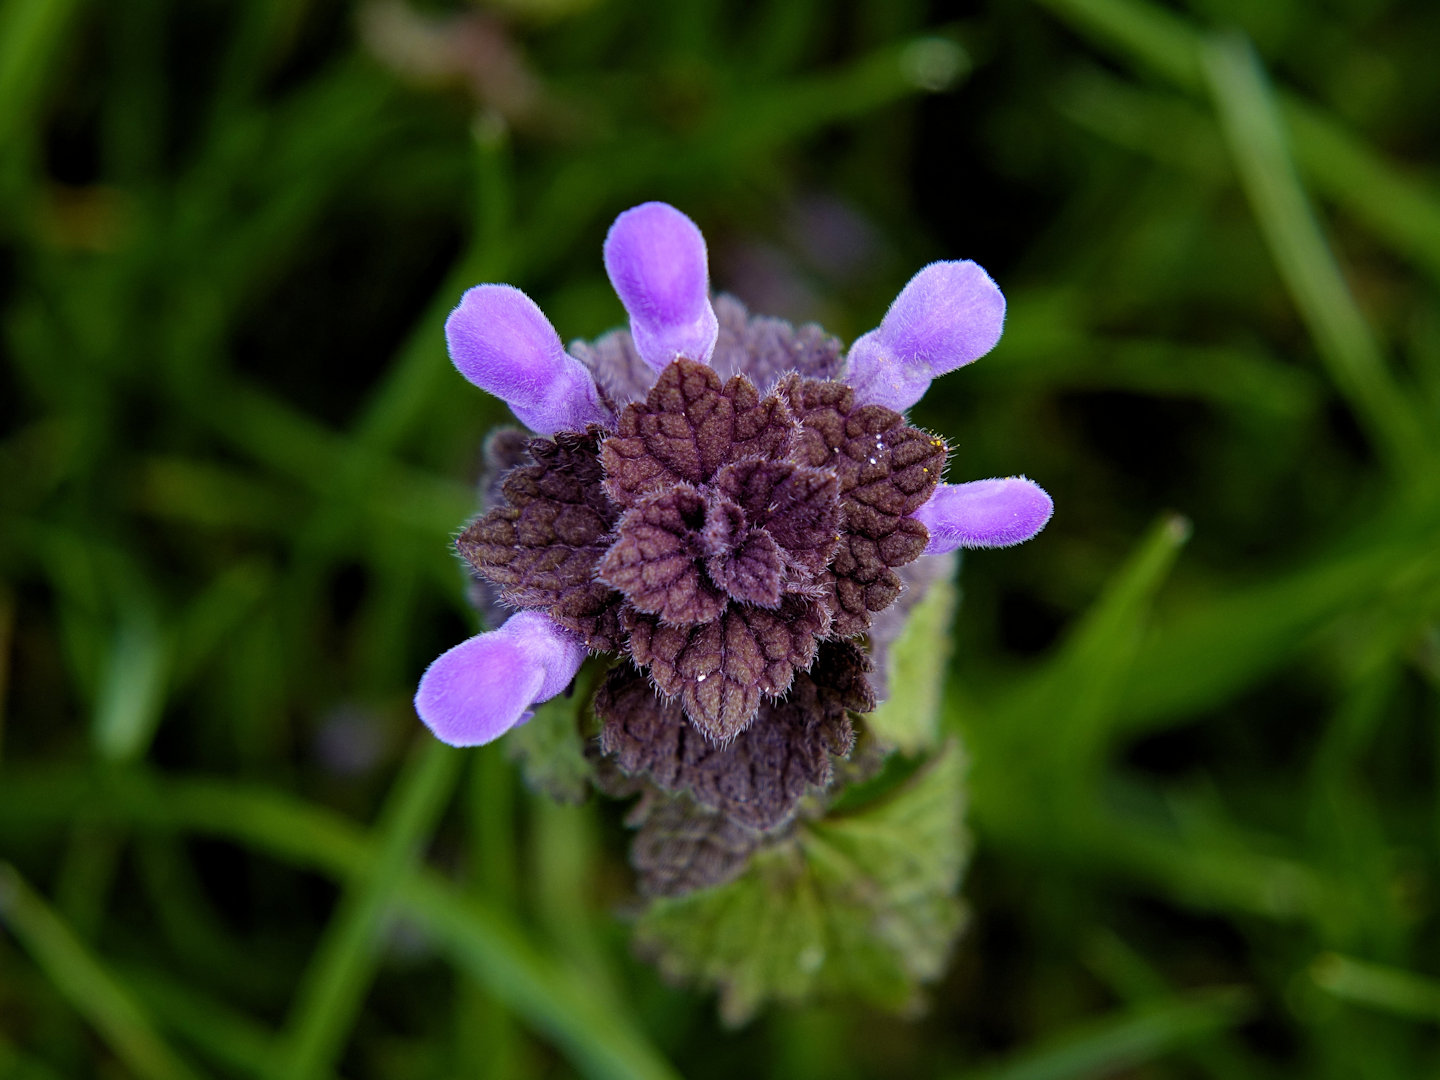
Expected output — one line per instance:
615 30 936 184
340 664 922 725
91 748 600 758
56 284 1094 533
0 864 196 1080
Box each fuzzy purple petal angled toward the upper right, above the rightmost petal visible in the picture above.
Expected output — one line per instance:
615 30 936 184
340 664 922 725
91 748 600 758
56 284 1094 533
845 259 1005 412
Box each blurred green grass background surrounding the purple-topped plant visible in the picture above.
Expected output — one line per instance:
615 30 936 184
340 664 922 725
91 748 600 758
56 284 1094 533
0 0 1440 1080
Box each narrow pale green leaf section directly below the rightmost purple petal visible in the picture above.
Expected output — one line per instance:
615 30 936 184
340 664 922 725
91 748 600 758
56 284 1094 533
865 560 959 755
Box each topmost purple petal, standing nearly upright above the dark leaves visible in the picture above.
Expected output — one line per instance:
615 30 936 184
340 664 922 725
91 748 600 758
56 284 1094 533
605 203 720 372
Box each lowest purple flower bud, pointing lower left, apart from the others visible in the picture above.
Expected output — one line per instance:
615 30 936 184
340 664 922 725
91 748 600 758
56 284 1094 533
415 611 585 746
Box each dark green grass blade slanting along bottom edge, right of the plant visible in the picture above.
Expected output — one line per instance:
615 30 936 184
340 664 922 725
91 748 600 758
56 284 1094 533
956 988 1254 1080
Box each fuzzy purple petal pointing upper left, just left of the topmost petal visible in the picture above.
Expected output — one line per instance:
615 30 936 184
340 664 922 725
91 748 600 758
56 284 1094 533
445 285 611 435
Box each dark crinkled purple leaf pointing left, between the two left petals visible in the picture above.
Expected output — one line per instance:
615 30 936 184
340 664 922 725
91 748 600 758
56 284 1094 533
455 429 622 651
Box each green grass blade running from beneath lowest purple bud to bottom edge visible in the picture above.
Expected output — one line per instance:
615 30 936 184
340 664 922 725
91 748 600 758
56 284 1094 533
275 739 464 1080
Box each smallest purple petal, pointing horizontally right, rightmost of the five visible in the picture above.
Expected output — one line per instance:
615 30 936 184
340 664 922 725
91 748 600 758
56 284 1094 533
913 477 1056 554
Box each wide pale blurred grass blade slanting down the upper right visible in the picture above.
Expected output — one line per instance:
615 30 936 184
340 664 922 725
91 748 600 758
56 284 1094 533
1202 35 1424 468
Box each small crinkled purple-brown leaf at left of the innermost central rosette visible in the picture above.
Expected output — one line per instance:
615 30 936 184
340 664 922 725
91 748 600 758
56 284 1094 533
596 484 726 626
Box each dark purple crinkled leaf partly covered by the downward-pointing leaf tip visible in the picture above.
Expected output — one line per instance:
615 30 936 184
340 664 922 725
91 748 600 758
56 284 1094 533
595 642 874 829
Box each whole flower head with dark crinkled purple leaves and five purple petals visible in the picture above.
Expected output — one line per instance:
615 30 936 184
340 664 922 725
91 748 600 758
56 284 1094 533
416 203 1053 864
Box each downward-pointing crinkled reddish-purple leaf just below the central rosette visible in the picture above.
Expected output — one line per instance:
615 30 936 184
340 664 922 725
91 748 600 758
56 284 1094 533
625 596 828 743
